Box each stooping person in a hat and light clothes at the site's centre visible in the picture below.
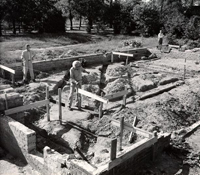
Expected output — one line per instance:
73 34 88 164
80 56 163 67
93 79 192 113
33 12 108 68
68 61 89 110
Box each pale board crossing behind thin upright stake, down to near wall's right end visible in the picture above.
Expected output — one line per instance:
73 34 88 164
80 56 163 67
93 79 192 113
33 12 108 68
111 119 153 138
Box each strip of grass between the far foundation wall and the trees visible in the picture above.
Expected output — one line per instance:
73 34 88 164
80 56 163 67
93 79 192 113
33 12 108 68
0 32 157 64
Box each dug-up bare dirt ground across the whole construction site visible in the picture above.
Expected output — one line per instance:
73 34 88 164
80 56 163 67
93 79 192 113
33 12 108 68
0 36 200 175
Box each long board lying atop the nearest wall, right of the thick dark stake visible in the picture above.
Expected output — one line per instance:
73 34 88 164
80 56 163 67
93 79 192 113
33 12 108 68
108 137 157 170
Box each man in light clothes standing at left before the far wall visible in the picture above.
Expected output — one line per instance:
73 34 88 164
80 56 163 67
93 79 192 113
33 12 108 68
21 44 35 83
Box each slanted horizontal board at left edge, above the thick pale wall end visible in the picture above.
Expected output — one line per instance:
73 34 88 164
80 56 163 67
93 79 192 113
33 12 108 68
5 100 49 115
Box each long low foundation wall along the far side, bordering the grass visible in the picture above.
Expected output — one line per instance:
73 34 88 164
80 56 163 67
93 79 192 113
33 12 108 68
2 48 151 80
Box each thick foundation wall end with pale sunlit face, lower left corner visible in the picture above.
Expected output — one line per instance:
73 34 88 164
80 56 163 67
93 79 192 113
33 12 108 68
0 116 36 162
